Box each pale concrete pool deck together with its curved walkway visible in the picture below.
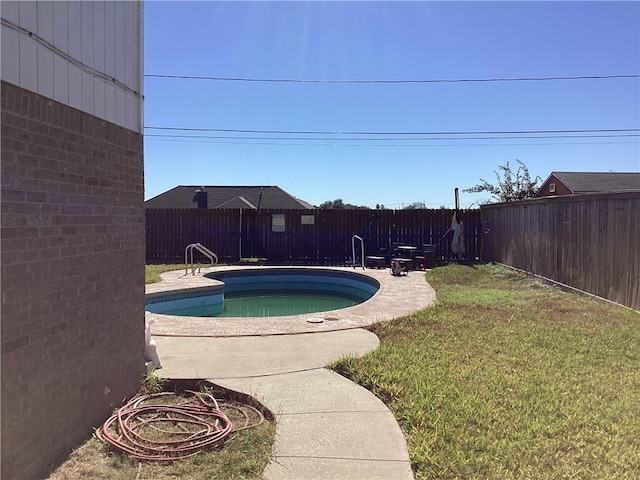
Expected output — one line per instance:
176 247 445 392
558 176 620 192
147 267 435 480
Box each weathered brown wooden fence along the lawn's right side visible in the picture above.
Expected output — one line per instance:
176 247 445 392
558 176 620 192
481 192 640 310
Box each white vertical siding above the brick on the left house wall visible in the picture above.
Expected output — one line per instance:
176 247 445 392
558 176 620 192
0 0 143 132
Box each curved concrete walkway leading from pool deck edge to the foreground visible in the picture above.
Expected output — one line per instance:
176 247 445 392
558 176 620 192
156 329 413 480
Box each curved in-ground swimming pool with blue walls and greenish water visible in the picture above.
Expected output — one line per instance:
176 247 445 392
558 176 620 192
145 268 380 317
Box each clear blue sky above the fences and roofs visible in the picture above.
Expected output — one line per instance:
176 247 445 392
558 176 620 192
144 1 640 208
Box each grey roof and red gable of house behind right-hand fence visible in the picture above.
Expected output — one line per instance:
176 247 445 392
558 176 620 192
536 172 640 197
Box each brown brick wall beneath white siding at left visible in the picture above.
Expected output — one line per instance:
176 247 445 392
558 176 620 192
0 82 144 479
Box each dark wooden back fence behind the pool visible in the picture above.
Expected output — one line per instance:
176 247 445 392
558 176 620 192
145 209 482 265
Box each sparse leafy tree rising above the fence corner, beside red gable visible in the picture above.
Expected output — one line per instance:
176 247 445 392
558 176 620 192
463 159 542 202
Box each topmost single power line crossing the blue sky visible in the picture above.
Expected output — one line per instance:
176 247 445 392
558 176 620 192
144 74 640 84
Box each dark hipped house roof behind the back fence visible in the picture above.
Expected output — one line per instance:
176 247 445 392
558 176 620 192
144 185 315 209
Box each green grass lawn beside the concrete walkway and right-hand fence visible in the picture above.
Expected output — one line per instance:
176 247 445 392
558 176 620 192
332 265 640 479
